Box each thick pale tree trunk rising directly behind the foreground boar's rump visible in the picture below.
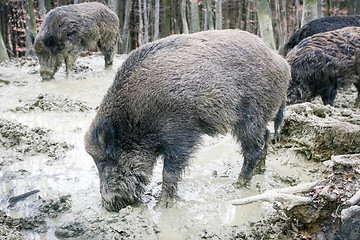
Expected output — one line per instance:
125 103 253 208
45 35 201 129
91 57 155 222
255 0 275 49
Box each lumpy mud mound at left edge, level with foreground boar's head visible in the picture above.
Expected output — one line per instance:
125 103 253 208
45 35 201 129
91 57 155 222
0 119 73 164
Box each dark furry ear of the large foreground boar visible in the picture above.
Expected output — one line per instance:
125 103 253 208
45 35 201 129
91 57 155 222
94 119 115 157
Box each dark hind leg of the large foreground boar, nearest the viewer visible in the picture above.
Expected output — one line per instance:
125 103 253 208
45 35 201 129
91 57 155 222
234 108 270 186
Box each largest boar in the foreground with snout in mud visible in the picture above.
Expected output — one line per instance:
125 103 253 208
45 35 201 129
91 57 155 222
85 30 290 211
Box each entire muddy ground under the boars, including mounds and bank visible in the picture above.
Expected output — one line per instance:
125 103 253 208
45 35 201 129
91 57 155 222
0 54 360 240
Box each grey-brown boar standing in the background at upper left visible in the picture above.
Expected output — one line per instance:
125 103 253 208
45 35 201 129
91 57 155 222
34 2 119 80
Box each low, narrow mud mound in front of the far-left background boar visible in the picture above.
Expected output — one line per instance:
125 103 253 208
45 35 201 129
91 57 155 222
11 94 92 113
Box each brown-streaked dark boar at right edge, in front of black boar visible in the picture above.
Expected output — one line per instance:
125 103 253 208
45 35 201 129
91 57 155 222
286 27 360 105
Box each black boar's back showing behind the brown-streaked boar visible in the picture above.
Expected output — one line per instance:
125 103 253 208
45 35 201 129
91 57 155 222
279 16 360 57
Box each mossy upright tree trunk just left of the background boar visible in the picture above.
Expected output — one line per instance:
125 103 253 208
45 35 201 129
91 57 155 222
25 0 36 56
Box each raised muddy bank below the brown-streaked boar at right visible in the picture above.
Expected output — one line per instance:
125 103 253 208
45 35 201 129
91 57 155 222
278 103 360 161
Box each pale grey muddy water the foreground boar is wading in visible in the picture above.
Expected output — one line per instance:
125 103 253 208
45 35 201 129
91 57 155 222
0 55 323 239
